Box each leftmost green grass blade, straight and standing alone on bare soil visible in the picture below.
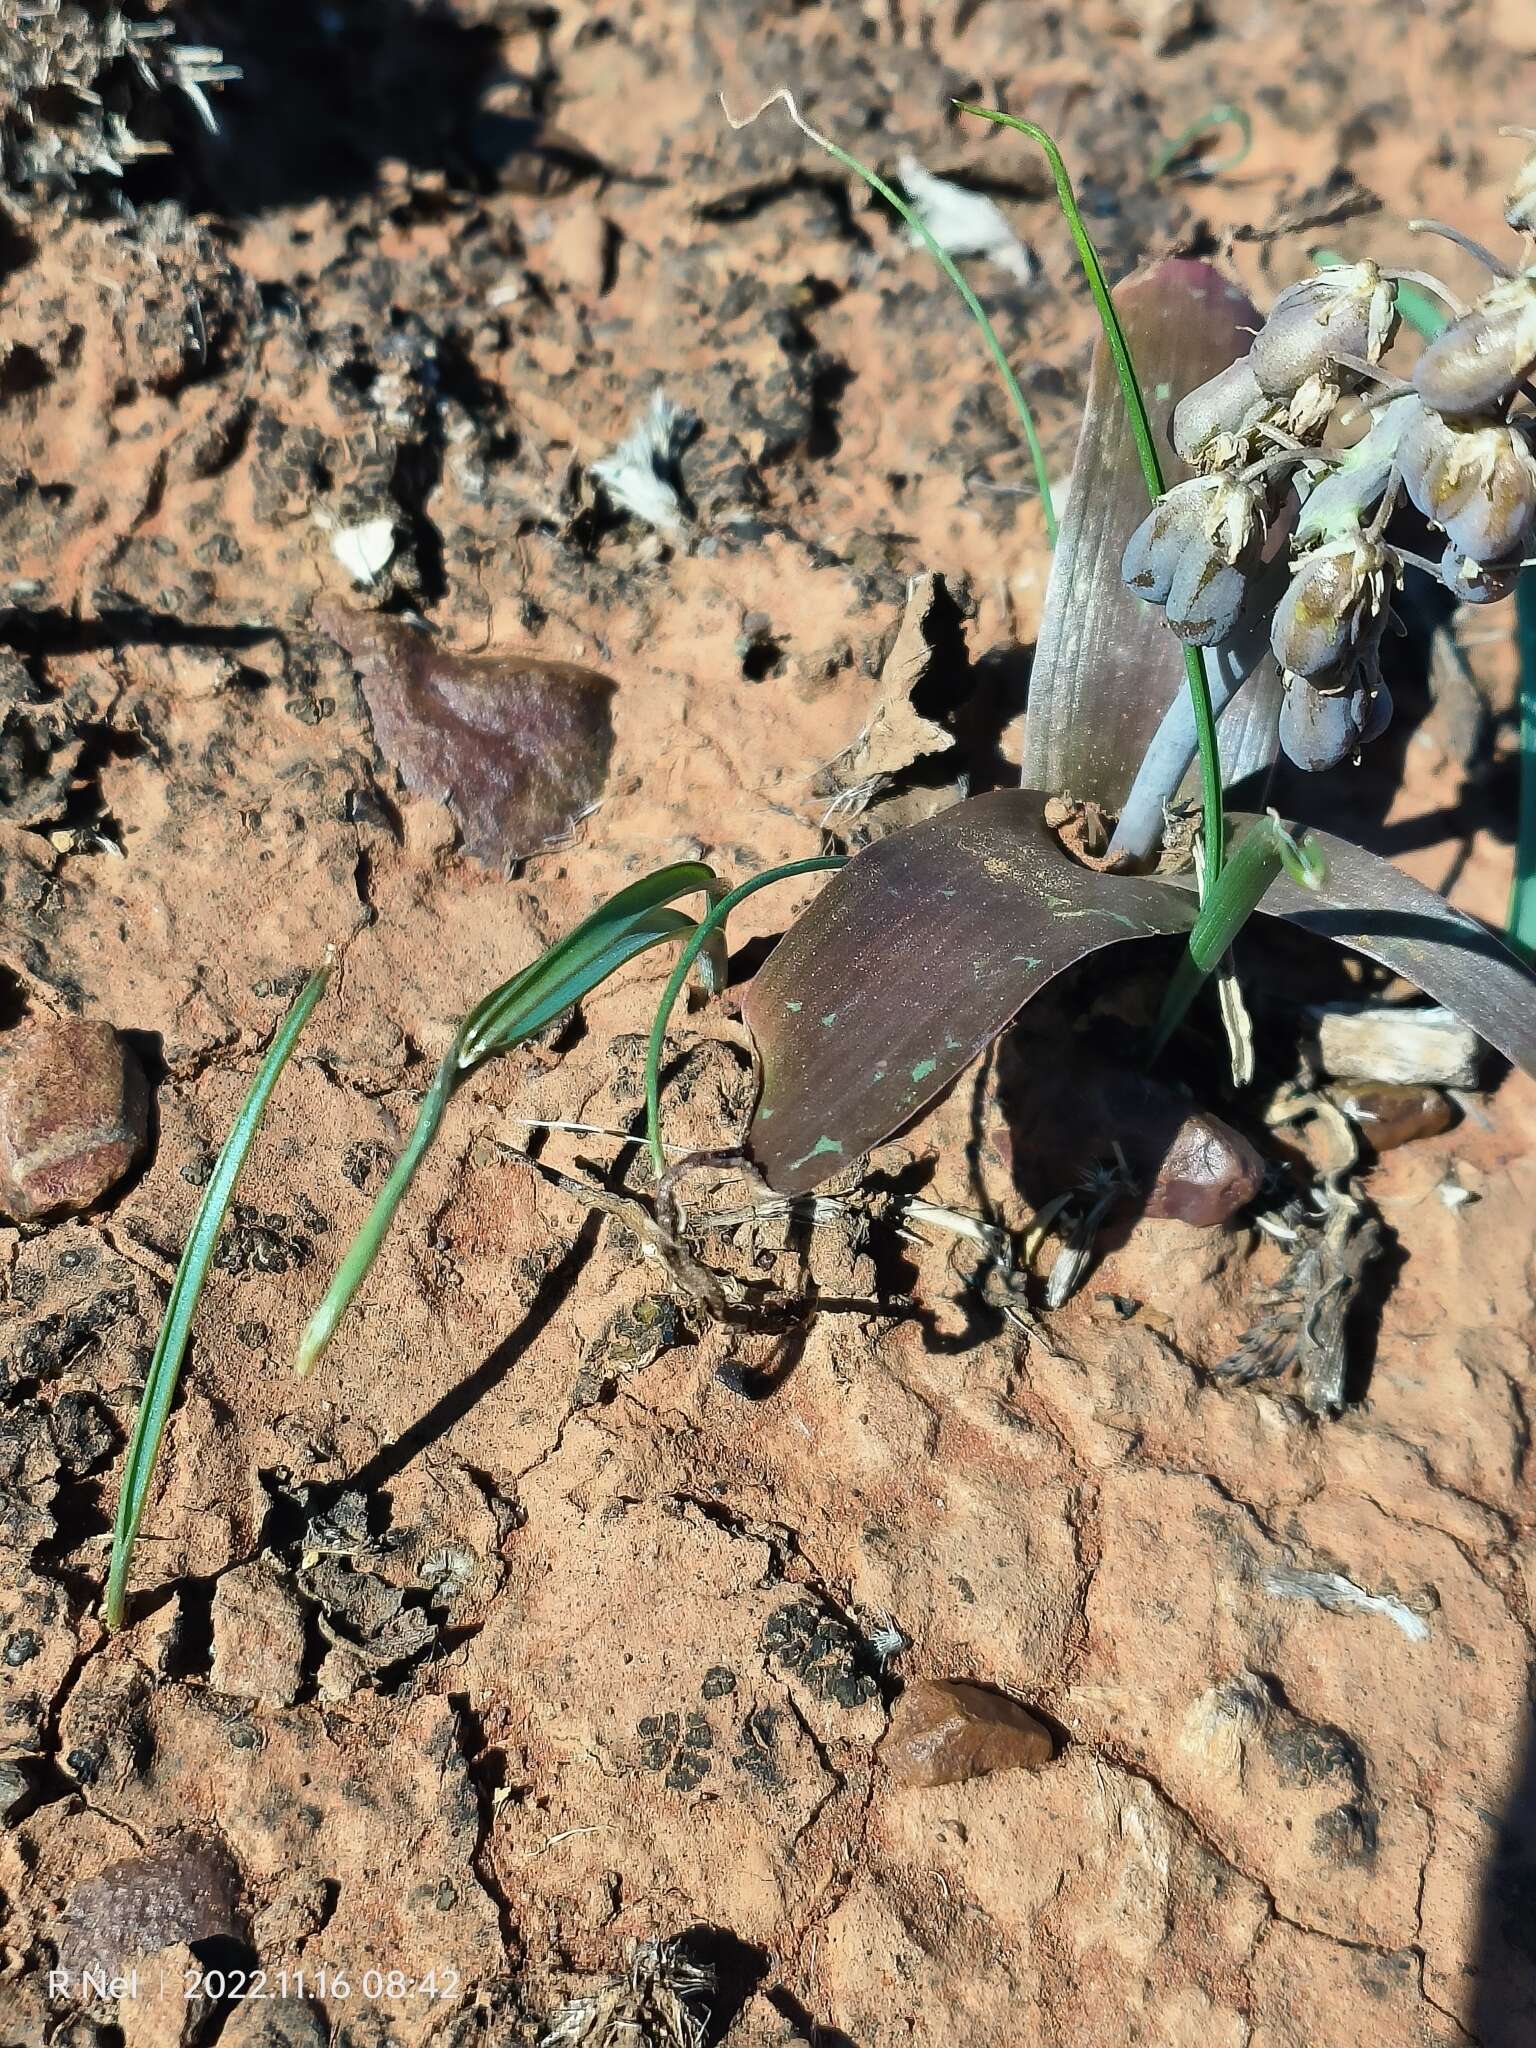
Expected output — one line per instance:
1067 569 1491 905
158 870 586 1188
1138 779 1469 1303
104 963 330 1628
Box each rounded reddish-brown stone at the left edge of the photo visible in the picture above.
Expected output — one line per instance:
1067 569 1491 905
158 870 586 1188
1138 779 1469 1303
0 1018 150 1223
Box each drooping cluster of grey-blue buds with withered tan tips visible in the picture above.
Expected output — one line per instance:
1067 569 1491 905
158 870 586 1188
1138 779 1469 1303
1120 151 1536 786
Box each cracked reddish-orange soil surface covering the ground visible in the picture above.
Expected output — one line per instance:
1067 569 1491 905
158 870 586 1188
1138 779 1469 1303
0 0 1536 2048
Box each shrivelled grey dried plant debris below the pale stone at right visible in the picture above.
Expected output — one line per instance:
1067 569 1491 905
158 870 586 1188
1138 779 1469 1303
1212 1182 1382 1419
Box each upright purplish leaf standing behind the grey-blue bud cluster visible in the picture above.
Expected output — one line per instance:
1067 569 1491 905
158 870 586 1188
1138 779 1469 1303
1020 258 1280 823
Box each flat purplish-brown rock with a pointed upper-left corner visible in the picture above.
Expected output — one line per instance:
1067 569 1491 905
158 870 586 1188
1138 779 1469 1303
315 598 612 866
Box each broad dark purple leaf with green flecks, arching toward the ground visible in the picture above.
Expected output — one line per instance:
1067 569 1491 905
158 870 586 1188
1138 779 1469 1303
743 788 1194 1194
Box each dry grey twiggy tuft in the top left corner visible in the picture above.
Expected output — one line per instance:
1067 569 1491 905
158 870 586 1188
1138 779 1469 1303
0 0 240 195
